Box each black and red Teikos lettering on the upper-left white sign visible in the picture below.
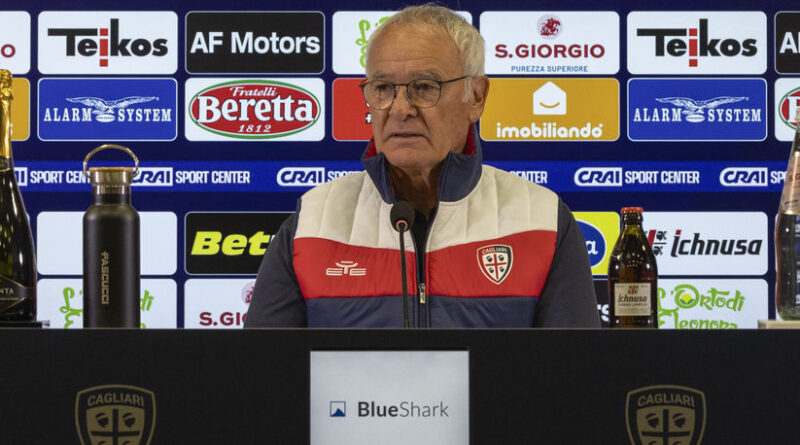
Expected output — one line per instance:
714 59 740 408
47 18 168 67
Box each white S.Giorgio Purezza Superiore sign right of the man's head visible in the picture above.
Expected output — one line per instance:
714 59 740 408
480 11 620 76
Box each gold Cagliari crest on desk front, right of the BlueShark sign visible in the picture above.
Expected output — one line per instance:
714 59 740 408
625 385 706 445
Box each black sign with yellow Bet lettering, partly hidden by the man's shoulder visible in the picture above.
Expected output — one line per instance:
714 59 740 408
184 212 290 275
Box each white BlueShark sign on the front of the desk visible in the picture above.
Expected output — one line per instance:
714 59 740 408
309 351 469 445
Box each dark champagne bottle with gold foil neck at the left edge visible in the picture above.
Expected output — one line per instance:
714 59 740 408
0 70 36 322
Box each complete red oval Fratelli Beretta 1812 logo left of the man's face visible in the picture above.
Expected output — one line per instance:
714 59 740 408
189 80 320 139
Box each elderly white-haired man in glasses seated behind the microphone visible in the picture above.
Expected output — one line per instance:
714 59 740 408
245 5 600 328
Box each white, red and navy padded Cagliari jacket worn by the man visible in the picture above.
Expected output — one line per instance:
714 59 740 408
245 126 600 328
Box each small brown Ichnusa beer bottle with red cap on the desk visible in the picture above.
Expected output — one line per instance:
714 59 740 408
608 207 658 328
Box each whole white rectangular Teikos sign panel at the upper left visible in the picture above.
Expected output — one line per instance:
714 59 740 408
38 11 178 74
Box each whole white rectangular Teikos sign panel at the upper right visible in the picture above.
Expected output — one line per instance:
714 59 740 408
627 11 767 75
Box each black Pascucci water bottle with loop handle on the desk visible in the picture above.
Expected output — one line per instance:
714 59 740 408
83 144 141 328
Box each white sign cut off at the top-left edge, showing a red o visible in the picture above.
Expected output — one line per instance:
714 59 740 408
0 11 31 73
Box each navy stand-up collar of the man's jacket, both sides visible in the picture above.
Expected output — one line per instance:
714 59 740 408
361 125 483 204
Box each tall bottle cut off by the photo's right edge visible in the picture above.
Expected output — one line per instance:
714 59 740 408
775 109 800 320
